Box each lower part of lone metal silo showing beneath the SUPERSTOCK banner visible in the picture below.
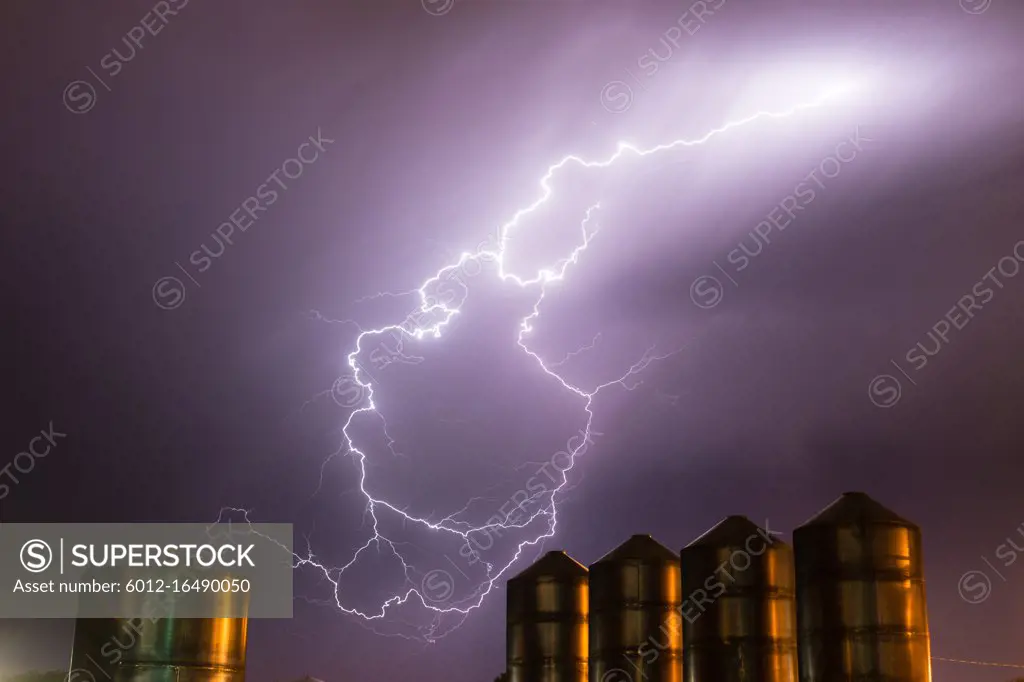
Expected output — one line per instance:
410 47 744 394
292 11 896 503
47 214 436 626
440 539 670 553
68 619 248 682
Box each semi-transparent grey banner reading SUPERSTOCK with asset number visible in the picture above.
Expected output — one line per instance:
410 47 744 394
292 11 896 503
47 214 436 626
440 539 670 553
0 522 294 619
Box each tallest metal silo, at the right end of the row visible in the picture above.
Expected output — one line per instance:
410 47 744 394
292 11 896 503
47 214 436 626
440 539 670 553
793 493 932 682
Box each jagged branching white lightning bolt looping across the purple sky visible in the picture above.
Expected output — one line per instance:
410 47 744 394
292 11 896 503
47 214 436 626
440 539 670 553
228 88 846 641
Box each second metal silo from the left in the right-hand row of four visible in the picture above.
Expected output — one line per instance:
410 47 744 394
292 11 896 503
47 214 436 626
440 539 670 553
590 536 683 682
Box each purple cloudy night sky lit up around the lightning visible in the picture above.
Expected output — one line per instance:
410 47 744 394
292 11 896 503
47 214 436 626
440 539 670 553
0 0 1024 682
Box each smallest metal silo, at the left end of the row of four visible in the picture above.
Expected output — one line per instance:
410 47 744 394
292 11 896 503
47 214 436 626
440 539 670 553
506 552 589 682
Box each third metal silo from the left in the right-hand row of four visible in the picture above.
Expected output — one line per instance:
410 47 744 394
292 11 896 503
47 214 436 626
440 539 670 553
680 516 797 682
